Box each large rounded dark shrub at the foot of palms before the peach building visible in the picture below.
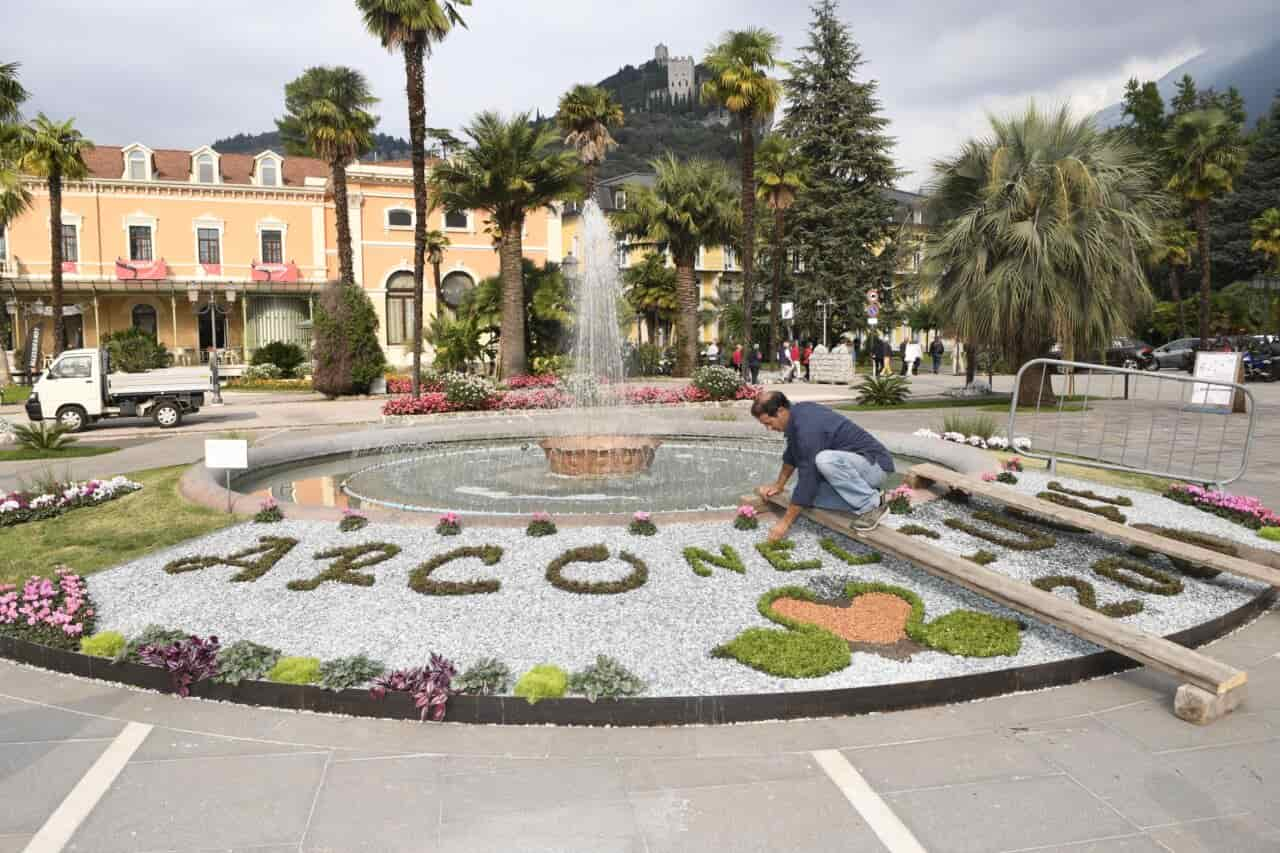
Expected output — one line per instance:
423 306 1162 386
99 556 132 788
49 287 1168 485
312 282 387 397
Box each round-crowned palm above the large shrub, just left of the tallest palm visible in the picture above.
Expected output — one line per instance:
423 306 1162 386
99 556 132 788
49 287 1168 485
275 65 378 292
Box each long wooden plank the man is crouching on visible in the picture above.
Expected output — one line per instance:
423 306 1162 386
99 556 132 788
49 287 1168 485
769 494 1248 695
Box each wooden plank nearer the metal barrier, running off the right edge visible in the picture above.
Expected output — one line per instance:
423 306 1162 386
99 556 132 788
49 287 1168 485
910 462 1280 587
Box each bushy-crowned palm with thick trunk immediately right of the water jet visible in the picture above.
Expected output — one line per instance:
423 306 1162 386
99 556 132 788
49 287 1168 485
613 154 741 377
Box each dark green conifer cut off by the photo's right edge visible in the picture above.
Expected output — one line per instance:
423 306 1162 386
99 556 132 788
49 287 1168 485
1212 92 1280 283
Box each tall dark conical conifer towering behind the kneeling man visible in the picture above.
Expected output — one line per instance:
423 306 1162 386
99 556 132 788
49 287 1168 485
782 0 901 323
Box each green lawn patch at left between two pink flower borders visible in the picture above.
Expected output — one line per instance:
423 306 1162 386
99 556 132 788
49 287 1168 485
0 466 238 584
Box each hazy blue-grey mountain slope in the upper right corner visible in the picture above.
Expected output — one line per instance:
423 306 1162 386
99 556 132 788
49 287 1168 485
1093 40 1280 129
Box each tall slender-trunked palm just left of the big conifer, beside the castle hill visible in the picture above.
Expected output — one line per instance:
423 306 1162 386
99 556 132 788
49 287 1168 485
701 29 782 364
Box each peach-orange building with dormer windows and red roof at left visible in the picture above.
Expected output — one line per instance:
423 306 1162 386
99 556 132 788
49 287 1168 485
0 142 562 364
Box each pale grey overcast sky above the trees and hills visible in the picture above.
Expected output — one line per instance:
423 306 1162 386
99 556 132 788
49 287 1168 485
10 0 1277 190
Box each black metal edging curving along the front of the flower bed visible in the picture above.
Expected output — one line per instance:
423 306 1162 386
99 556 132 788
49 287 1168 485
0 589 1276 726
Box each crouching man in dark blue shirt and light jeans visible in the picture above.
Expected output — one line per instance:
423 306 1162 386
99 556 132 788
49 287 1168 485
751 391 893 542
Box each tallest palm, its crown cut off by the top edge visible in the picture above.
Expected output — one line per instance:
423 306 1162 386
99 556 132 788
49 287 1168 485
356 0 471 397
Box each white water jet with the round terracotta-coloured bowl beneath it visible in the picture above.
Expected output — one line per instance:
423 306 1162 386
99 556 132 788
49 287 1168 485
539 200 662 476
